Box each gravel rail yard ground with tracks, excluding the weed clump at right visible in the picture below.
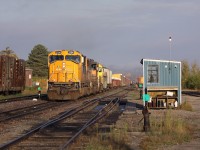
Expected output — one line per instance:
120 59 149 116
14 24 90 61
0 88 200 150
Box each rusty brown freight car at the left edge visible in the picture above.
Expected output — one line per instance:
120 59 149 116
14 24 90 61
0 55 25 95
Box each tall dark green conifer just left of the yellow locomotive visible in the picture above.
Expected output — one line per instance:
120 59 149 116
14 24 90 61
26 44 49 77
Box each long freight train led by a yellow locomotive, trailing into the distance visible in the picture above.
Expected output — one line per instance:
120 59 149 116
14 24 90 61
47 50 130 100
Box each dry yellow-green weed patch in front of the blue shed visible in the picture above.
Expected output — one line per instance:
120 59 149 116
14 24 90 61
140 110 191 149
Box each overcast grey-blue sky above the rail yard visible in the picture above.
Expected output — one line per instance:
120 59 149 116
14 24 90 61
0 0 200 77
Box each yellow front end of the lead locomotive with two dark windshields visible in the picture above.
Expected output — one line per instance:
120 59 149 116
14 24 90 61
47 50 86 100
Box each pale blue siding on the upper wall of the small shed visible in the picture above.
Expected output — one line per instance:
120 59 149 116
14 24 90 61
142 59 181 104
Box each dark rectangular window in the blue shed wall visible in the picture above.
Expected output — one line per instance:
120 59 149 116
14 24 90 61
148 65 159 83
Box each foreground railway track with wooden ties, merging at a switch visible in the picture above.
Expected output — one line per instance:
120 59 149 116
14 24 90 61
0 88 125 149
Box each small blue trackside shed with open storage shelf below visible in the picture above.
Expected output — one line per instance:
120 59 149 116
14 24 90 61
141 59 181 108
